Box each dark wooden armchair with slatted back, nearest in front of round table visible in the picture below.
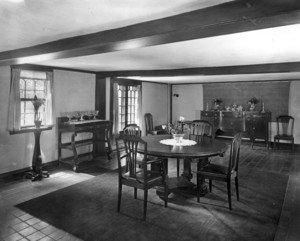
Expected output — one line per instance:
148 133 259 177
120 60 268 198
116 134 168 220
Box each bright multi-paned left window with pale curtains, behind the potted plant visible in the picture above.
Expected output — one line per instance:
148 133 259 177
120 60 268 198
8 68 54 131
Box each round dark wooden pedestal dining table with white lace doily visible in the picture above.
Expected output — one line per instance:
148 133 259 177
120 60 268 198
141 134 229 197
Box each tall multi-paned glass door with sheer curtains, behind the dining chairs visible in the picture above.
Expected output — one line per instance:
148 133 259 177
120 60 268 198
113 81 141 134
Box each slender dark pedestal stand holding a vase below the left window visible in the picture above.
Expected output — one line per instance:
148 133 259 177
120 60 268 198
9 125 53 181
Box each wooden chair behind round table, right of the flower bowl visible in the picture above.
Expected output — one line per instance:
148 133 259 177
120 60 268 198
177 120 214 176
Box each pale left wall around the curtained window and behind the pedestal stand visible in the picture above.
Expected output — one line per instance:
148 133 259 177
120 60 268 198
0 67 95 174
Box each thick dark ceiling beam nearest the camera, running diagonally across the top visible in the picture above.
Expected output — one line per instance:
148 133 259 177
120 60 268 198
0 0 300 65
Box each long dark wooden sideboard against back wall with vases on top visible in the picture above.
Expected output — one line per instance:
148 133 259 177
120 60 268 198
201 110 271 147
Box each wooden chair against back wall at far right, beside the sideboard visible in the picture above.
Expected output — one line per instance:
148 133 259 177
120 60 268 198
274 115 295 152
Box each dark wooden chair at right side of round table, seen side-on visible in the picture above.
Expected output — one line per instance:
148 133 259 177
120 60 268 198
197 132 242 210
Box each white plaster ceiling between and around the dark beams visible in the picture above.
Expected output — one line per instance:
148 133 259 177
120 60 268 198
0 0 300 83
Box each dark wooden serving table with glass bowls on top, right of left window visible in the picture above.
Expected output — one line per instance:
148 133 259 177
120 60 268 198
57 117 111 171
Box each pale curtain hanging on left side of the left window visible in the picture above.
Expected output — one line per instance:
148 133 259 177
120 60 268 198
7 69 21 131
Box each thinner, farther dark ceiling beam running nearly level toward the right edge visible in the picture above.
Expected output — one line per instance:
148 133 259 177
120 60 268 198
97 62 300 77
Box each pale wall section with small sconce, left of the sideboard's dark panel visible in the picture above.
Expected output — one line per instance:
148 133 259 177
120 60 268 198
172 84 203 122
